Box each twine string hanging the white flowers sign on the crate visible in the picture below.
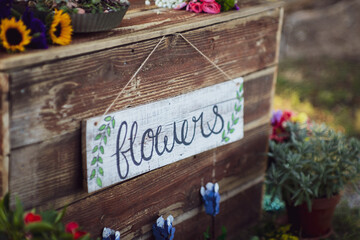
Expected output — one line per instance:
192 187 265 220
102 33 232 116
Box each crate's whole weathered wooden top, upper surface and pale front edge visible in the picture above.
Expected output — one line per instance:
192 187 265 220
0 1 283 70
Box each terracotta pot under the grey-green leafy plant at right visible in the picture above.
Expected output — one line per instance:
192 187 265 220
287 194 341 239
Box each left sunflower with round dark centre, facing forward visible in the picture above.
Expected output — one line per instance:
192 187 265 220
0 17 31 52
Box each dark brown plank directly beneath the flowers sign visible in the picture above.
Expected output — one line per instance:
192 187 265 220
65 124 269 239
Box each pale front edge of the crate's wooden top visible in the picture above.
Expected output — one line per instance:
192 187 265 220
0 2 283 71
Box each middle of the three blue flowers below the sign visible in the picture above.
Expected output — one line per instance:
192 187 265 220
153 215 175 240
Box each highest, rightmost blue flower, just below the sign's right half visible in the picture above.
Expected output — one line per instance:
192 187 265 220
200 182 220 216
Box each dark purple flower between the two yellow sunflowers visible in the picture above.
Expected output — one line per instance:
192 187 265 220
21 8 48 49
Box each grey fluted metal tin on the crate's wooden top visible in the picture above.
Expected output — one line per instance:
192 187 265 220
70 6 129 33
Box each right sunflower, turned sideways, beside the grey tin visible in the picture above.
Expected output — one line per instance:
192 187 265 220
49 9 73 45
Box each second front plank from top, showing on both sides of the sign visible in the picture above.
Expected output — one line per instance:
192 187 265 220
10 68 274 208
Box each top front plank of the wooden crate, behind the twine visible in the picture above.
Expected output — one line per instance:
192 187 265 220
11 11 278 148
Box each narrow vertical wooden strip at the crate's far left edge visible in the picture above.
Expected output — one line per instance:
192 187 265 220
0 73 10 198
